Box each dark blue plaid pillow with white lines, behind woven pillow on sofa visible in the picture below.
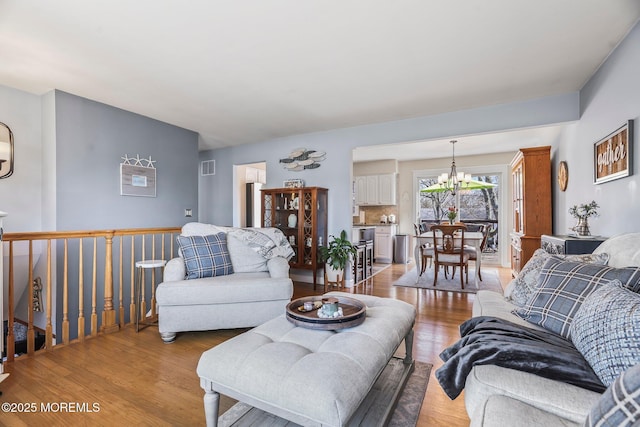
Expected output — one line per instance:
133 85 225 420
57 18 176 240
513 257 640 338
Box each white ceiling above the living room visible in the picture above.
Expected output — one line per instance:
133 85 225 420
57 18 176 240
0 0 640 156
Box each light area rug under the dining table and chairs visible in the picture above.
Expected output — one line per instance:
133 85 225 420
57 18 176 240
393 267 502 294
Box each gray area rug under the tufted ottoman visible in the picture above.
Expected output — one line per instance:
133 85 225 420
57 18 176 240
218 358 433 427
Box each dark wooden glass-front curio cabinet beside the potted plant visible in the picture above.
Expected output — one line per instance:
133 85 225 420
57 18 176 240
261 187 328 287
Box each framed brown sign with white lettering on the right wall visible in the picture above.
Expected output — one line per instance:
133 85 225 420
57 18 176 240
593 120 633 184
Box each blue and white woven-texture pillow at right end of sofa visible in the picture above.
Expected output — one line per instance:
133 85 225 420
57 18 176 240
571 280 640 385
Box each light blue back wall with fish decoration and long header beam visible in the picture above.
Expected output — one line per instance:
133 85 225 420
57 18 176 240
200 93 579 234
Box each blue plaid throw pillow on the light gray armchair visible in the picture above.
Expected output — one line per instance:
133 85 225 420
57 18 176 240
178 233 233 279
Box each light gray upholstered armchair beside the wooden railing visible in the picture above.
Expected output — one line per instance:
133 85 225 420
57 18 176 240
156 222 293 343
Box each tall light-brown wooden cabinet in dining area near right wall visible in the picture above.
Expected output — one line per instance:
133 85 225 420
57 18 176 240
511 146 552 276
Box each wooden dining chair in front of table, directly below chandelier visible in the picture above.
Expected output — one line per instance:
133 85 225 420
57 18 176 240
431 224 469 289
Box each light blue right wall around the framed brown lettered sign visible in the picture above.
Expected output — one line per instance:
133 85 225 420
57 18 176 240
553 20 640 236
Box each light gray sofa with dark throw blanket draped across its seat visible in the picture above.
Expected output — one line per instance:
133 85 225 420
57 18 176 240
464 233 640 427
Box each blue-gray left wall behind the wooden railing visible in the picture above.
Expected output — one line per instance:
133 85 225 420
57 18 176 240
0 86 198 334
